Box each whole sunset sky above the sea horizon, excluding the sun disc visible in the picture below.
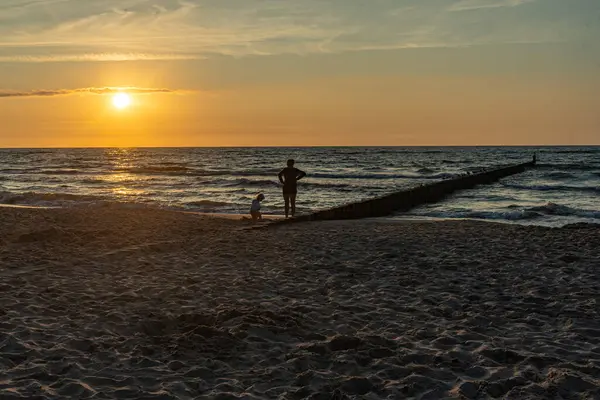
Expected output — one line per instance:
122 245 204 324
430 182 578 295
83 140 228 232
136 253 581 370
0 0 600 147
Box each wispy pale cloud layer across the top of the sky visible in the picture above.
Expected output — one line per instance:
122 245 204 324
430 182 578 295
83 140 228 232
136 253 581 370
0 0 600 61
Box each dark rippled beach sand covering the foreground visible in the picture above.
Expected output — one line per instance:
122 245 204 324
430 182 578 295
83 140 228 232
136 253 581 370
0 208 600 400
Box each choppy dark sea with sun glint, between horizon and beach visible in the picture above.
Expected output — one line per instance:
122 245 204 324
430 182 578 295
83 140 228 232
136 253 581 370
0 147 600 226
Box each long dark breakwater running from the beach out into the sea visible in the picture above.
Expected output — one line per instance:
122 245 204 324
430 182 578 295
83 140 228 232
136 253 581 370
263 155 536 226
